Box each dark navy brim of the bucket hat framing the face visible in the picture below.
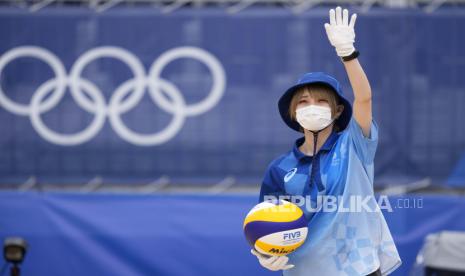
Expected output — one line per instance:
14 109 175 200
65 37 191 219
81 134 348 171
278 81 352 132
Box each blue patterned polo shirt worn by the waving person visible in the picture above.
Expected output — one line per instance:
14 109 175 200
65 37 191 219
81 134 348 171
260 118 401 276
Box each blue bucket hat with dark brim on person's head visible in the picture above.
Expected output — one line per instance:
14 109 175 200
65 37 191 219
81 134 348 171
278 72 352 132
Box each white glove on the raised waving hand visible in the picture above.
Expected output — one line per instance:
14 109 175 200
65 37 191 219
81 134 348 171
325 7 357 57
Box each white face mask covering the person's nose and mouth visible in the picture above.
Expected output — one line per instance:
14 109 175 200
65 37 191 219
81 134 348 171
296 105 333 131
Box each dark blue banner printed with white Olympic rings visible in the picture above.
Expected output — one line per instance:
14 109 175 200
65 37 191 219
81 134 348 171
0 8 465 185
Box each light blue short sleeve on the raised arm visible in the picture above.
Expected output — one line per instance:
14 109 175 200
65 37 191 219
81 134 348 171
347 117 378 165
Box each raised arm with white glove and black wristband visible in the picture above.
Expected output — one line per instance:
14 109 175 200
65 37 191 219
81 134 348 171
325 7 372 137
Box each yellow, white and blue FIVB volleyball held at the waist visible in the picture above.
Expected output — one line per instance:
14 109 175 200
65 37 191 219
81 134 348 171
243 200 308 256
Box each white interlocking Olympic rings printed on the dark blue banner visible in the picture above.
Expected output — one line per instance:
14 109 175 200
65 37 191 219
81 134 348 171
0 46 226 146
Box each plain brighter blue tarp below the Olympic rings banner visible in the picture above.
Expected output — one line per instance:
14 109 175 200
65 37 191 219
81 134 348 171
0 192 465 276
